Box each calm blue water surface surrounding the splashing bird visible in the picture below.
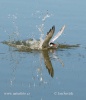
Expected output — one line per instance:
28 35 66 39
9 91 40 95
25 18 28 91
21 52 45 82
0 0 86 100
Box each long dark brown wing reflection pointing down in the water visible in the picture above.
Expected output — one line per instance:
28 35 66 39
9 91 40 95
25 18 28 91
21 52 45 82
42 50 54 77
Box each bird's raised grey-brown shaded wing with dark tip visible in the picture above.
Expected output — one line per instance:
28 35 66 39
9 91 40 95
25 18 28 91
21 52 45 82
42 26 55 48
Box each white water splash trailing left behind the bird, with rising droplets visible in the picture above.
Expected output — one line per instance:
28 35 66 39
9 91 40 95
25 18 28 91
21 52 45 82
3 11 51 50
